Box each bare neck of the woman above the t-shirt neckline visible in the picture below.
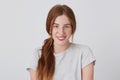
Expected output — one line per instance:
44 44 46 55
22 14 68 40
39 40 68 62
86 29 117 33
54 42 70 54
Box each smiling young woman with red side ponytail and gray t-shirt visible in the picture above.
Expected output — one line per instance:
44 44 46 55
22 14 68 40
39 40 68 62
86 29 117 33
27 5 95 80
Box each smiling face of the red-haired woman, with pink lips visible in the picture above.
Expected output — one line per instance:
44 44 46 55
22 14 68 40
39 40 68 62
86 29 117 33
52 15 72 46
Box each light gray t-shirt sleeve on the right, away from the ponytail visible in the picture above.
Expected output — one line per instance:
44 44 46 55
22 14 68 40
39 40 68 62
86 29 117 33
81 46 96 68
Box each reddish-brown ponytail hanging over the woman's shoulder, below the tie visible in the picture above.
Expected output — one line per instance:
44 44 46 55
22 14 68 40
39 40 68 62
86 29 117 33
37 37 55 80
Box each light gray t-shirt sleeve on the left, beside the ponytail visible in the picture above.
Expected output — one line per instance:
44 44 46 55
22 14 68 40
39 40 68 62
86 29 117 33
26 49 41 71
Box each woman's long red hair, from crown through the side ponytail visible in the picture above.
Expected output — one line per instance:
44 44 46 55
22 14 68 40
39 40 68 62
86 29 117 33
37 5 76 80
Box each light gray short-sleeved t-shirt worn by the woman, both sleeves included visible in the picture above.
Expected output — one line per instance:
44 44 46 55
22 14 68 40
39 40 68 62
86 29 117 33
27 43 95 80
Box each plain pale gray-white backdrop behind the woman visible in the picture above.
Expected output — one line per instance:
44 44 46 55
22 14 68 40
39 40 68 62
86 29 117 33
0 0 120 80
